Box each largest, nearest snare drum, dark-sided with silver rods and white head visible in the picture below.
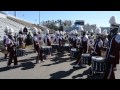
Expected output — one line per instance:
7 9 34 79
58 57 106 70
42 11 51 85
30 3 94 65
92 56 105 73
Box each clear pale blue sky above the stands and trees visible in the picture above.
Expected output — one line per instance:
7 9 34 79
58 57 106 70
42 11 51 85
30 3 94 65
5 11 120 27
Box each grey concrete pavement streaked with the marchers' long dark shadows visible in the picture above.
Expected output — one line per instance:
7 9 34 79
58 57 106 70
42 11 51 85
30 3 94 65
0 48 120 79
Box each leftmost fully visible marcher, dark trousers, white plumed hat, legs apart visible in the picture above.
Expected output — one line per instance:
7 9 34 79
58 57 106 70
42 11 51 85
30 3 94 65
6 28 18 67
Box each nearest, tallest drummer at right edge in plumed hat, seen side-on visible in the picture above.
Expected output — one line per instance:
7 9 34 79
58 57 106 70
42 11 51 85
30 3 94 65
104 16 120 79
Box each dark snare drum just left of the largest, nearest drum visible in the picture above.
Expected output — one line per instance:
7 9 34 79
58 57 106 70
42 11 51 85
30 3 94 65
81 53 92 65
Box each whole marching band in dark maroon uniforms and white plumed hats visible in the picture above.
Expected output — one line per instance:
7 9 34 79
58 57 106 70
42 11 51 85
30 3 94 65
0 16 120 79
